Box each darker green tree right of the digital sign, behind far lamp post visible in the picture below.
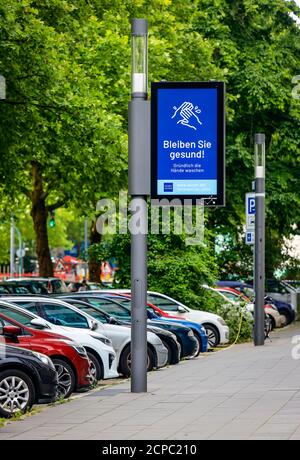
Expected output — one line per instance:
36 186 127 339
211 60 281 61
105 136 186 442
192 0 300 276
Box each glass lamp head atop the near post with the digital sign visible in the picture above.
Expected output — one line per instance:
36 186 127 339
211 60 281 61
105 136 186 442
131 19 148 99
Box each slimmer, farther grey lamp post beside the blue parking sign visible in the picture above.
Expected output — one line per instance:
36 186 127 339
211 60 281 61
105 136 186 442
254 134 265 346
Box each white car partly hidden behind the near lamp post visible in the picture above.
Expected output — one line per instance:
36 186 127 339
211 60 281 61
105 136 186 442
5 296 168 376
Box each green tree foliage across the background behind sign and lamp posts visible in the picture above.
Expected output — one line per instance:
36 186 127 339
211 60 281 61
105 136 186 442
0 0 300 276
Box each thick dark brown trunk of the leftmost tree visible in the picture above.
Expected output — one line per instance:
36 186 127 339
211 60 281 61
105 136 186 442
31 162 53 277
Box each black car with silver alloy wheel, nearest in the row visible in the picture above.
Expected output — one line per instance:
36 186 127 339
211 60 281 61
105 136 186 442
0 342 57 417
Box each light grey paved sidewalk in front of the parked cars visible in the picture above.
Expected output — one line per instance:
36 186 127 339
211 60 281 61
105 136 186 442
0 325 300 440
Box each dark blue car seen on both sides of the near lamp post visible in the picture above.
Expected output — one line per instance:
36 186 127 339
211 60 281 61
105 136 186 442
59 294 200 364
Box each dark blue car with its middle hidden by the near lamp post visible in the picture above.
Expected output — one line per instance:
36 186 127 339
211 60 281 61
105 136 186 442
58 293 200 364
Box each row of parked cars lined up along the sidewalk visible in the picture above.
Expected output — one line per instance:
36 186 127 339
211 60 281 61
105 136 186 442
0 278 292 417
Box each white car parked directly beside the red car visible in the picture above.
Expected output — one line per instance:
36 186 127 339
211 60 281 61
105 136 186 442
0 298 119 381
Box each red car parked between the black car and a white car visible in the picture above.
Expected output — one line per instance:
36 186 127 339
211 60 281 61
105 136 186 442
0 312 91 398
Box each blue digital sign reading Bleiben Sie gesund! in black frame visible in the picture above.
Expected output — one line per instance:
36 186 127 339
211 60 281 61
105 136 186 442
151 82 224 205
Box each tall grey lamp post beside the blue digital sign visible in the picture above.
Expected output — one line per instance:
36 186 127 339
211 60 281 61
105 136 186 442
128 19 150 393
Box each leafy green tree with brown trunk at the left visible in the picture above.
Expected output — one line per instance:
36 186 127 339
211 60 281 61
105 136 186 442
0 0 126 276
